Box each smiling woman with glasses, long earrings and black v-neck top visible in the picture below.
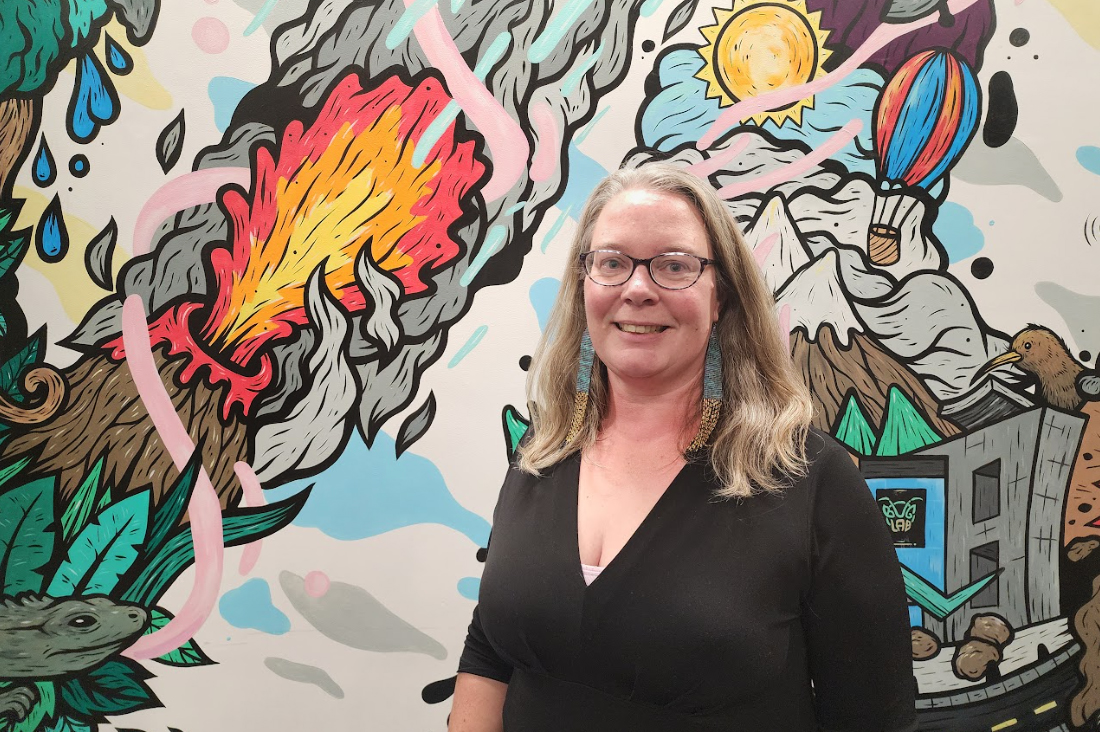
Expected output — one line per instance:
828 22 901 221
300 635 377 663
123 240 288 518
450 164 916 732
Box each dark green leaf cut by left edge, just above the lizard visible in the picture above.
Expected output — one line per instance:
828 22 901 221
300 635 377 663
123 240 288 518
0 478 56 596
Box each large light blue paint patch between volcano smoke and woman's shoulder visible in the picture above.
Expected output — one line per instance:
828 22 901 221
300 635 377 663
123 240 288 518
267 430 490 547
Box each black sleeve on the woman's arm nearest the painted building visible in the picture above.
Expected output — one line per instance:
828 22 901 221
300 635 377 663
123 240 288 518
803 445 916 732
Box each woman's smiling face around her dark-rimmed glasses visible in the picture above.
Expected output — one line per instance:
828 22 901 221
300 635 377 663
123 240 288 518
584 189 718 393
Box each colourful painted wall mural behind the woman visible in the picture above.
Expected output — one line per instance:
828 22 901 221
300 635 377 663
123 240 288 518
0 0 1100 732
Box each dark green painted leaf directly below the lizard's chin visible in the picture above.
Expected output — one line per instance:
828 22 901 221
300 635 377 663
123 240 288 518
61 658 162 722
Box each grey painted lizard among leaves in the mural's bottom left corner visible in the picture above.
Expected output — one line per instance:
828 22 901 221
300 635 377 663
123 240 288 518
0 594 149 723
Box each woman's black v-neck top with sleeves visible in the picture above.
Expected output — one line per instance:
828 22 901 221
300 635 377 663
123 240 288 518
459 430 916 732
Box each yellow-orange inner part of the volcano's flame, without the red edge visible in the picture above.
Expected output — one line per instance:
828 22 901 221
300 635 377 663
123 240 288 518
207 107 441 348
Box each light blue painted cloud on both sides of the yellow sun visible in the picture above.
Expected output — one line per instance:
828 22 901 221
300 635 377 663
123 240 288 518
639 48 883 176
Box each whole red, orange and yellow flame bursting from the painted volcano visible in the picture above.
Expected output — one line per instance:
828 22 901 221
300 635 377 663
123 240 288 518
202 75 484 364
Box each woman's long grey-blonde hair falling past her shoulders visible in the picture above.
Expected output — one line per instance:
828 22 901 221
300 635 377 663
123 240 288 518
518 163 813 498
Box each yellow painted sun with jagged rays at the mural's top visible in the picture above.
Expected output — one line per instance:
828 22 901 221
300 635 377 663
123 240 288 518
695 0 831 125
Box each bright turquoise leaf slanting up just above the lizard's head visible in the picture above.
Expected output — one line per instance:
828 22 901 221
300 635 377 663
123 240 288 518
46 490 150 598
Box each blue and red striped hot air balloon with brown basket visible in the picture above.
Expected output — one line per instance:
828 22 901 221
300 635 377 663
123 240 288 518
868 48 981 264
